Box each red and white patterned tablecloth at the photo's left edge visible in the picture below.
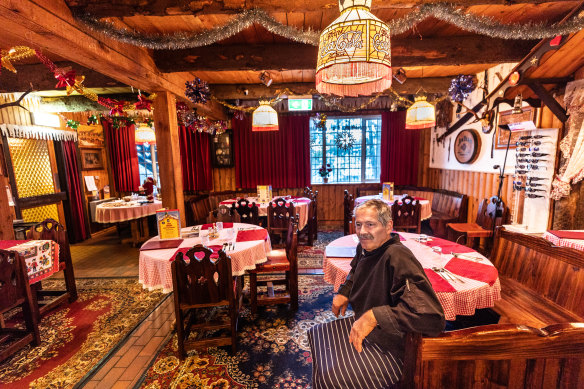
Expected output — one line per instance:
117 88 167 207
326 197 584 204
0 240 59 284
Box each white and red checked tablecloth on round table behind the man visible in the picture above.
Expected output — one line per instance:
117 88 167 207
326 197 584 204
323 232 501 320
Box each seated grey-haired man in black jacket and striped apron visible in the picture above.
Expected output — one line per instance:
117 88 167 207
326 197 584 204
309 200 445 389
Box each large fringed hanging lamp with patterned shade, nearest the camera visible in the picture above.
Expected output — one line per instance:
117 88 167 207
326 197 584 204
316 0 392 96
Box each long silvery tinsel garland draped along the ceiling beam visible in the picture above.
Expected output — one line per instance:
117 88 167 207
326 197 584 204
75 3 584 50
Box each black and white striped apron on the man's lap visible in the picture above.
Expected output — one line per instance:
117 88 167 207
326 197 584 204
308 316 403 389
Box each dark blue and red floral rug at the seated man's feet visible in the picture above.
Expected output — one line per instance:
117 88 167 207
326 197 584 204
142 275 344 389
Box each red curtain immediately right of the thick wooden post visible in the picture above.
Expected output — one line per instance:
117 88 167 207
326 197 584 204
178 126 213 191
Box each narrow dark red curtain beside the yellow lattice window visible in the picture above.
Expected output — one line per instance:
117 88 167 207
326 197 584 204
61 141 89 242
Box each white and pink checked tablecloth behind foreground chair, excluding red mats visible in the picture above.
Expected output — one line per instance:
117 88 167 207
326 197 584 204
139 223 272 293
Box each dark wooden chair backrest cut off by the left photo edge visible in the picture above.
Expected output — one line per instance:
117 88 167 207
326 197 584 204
0 250 30 314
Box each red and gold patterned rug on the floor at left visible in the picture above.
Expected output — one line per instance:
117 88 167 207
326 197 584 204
0 278 166 389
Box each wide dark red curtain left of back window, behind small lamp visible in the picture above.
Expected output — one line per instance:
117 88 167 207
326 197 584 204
232 115 310 189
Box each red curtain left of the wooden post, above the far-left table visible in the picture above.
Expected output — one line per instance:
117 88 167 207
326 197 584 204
101 118 140 192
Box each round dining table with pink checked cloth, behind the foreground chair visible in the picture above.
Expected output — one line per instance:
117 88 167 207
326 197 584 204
139 222 272 293
